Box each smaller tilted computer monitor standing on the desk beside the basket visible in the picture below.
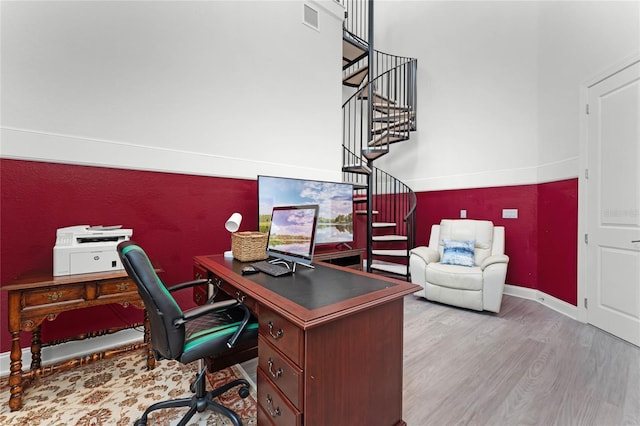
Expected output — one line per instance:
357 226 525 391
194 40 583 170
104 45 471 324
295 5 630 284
267 204 319 270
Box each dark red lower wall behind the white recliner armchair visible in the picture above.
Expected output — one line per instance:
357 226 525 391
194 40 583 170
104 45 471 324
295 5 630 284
417 179 578 305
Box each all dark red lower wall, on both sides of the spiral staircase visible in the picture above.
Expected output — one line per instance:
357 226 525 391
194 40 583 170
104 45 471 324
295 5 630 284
0 159 578 352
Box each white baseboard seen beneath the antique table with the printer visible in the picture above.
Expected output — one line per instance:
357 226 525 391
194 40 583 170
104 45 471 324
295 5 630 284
0 329 144 377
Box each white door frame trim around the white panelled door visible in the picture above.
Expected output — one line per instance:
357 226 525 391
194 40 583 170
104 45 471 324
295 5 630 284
576 52 640 323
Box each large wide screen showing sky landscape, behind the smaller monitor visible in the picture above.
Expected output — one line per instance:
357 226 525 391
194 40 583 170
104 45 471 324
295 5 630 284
258 176 354 244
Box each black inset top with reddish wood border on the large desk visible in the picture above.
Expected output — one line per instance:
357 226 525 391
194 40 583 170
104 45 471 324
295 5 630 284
195 255 420 325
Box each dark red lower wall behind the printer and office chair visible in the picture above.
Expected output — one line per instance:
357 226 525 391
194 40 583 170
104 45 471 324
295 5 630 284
0 159 258 352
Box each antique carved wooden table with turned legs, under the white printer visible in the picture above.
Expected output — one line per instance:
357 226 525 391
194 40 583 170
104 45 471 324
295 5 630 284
2 270 155 411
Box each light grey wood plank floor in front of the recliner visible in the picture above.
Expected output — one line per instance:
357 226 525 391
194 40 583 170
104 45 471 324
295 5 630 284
243 296 640 426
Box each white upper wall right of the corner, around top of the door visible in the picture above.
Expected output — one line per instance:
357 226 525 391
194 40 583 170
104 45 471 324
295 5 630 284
538 1 640 176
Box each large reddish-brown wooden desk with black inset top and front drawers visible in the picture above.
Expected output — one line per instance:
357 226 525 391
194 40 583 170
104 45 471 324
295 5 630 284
194 255 420 426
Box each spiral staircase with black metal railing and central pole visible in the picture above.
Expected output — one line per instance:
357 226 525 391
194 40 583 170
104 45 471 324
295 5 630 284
340 0 417 280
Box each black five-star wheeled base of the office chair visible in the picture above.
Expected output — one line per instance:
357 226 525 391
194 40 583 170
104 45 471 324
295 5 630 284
134 369 249 426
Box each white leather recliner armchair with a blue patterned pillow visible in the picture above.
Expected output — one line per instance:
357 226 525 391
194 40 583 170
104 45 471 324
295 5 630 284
409 219 509 312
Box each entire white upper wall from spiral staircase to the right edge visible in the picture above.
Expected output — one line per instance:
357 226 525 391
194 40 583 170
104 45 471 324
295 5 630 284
375 0 640 191
